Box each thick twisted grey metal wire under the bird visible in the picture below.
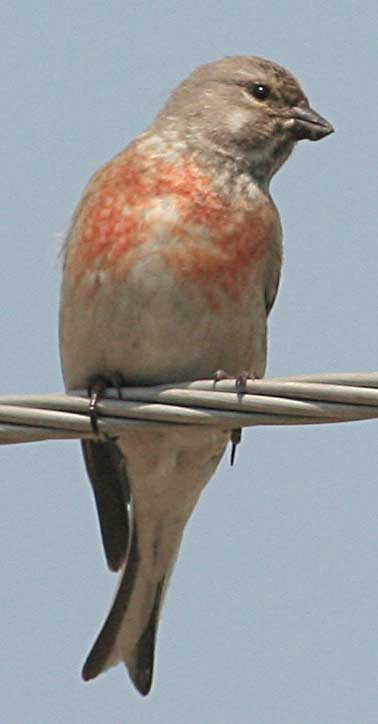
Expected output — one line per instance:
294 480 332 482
0 372 378 445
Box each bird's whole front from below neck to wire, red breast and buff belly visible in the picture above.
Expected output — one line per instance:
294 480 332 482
60 153 280 387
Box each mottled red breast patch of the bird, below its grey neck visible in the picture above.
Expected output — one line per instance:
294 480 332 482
66 153 277 310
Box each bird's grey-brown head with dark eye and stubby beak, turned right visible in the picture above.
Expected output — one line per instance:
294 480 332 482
157 56 333 181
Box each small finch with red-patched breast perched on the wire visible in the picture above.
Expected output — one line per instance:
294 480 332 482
60 56 334 695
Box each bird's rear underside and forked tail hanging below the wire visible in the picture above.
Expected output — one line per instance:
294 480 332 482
82 429 228 695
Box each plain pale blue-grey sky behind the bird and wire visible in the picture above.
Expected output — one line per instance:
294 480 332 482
0 0 378 724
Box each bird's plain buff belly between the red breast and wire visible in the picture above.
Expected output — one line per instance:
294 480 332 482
61 256 266 389
